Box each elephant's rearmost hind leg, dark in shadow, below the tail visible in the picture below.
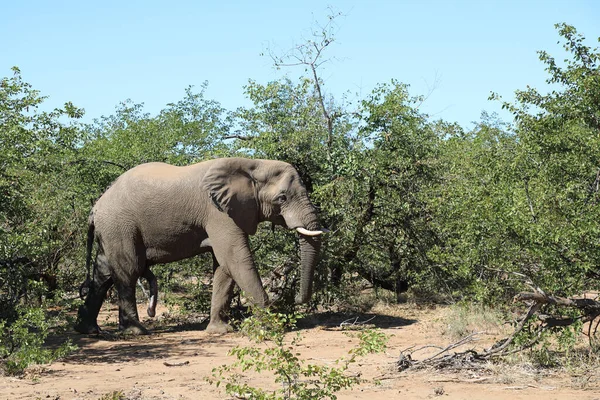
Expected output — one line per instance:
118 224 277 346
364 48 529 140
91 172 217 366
74 253 113 334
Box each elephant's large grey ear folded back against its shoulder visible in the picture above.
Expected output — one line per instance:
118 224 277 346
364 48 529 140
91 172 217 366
204 159 259 235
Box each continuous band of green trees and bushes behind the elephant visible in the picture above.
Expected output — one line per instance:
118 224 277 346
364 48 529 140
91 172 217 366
0 18 600 376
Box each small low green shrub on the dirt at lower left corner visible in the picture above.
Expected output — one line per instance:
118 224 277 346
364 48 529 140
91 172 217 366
0 308 77 375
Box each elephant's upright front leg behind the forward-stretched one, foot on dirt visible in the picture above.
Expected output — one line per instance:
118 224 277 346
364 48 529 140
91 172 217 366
206 266 234 333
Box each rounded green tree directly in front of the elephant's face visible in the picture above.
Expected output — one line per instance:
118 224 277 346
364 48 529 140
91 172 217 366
319 81 438 294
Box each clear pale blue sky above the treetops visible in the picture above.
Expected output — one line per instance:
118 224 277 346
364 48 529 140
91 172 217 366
0 0 600 128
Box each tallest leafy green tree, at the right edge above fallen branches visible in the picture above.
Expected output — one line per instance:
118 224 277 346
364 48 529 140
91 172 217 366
492 23 600 293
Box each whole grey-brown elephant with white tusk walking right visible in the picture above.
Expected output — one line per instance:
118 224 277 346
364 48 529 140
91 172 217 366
75 158 323 334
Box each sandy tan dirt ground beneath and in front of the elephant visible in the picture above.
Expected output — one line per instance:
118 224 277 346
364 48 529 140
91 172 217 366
0 305 600 400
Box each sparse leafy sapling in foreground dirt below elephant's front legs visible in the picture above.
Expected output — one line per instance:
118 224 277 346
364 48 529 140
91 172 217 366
207 309 387 400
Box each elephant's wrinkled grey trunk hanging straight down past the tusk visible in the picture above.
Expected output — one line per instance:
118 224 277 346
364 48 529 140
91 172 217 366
296 218 321 304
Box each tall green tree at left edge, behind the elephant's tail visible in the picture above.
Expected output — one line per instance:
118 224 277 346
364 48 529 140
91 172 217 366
0 67 83 320
